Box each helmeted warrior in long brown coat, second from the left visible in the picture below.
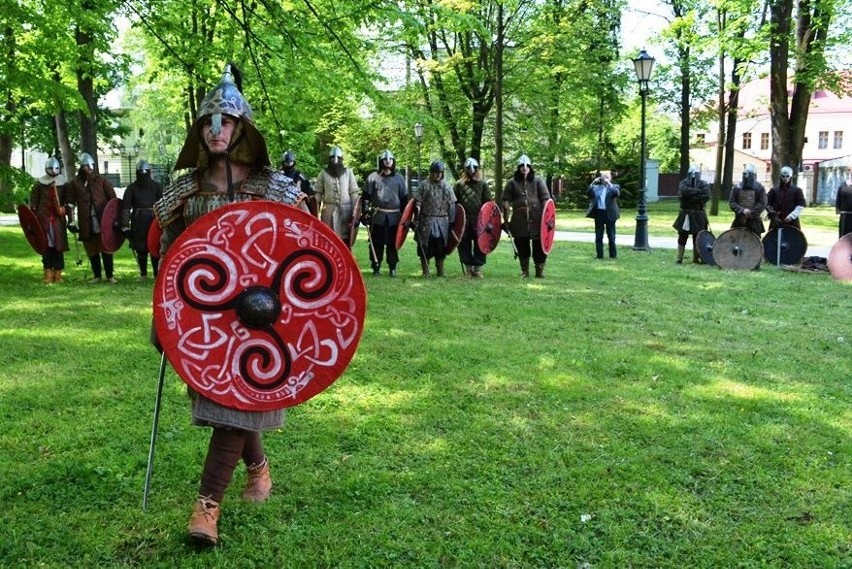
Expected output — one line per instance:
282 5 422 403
68 152 117 284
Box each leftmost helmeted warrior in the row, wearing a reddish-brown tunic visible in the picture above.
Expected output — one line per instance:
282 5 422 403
29 156 73 283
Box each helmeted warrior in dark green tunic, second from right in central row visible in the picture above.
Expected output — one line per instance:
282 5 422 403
455 157 494 278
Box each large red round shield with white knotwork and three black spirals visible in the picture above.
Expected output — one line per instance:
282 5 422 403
153 201 367 411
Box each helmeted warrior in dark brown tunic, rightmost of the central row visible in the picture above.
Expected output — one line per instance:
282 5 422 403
501 154 550 278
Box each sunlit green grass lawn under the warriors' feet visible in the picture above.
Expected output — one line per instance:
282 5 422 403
0 205 852 568
